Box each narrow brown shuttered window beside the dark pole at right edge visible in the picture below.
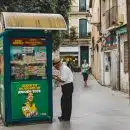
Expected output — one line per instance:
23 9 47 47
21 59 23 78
124 41 128 73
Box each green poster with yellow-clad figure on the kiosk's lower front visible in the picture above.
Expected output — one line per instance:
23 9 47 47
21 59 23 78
11 80 48 119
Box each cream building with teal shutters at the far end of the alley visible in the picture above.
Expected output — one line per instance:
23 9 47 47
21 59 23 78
60 0 91 66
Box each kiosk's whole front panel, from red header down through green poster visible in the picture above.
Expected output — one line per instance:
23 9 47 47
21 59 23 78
10 38 48 120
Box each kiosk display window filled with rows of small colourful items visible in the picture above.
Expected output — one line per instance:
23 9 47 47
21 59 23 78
10 46 47 80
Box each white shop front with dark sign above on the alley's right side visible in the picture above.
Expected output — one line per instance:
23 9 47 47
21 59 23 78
101 30 118 87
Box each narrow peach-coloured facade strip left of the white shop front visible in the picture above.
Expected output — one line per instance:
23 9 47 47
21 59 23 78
89 0 101 81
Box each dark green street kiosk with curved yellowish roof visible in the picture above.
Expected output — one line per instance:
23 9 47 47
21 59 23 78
0 12 66 125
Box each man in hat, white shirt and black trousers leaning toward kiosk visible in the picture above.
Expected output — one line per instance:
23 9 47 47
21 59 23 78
53 58 73 121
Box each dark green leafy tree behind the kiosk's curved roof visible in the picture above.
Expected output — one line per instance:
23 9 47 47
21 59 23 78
0 0 72 50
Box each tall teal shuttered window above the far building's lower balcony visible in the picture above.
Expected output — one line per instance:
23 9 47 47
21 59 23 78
79 19 87 38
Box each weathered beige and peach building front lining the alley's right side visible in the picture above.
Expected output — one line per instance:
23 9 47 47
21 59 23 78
89 0 129 92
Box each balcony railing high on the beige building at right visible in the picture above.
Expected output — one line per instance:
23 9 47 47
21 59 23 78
104 5 118 29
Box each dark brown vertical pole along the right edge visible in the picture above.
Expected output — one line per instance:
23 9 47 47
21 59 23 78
126 0 130 100
